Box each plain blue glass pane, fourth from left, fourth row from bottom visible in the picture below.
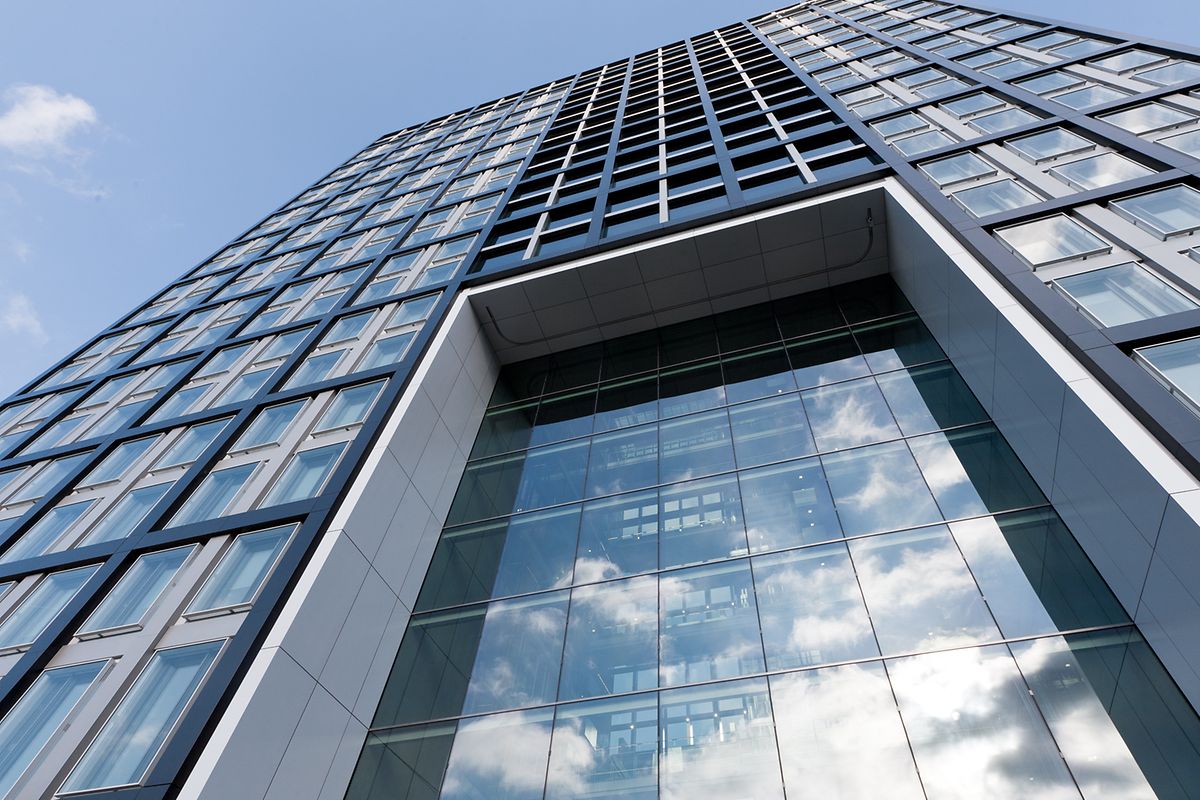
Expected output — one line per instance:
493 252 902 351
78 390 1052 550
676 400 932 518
730 393 816 468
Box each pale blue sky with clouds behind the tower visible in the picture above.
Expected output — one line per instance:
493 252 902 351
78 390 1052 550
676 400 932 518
0 0 1196 397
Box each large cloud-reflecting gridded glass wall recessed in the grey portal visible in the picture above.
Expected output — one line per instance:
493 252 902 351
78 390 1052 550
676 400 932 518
347 278 1200 800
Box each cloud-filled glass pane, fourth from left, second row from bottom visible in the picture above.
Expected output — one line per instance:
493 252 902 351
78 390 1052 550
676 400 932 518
752 543 880 670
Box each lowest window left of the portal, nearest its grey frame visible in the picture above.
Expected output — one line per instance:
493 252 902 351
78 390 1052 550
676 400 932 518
60 639 224 792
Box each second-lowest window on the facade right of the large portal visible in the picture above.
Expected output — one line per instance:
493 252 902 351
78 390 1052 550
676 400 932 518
1054 264 1196 326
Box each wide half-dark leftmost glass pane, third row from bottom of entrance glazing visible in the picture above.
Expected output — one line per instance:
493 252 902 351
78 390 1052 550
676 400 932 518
416 506 578 610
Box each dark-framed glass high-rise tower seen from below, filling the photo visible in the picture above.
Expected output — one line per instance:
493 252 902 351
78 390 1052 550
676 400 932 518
0 0 1200 800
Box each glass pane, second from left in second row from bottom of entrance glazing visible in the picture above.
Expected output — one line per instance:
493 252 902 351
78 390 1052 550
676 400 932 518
558 576 659 700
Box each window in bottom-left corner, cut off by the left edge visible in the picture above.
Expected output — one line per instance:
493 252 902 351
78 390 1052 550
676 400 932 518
0 661 108 798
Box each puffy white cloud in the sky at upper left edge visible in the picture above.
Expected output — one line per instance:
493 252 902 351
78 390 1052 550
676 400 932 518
0 85 100 158
